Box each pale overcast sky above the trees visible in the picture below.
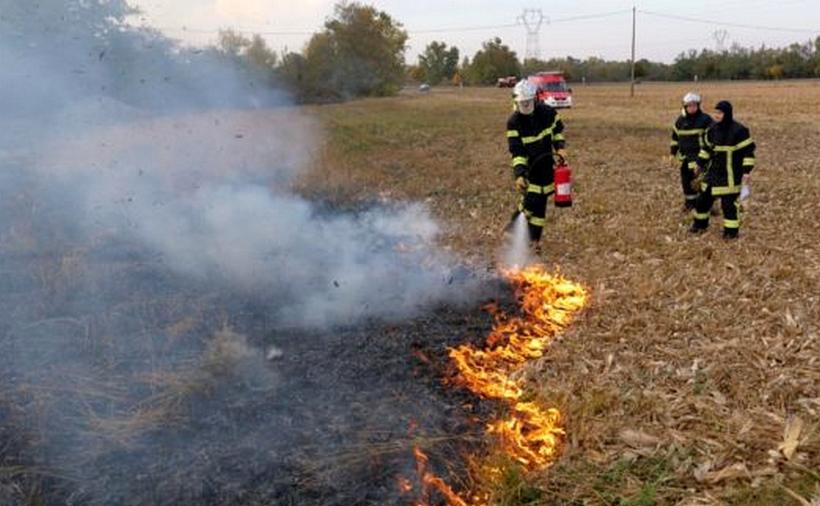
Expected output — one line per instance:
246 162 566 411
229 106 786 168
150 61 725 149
130 0 820 63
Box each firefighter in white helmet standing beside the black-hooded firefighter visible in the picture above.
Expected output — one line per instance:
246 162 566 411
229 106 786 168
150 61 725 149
670 91 712 212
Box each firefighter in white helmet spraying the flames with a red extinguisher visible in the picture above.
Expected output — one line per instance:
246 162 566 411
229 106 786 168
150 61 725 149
507 80 567 254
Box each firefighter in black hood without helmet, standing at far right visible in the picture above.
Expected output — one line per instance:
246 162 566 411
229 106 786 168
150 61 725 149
689 100 755 239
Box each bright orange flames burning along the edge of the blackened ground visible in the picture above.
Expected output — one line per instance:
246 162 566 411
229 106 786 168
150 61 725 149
406 265 587 506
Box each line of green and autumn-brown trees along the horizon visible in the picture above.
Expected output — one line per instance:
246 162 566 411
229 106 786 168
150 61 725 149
216 2 820 102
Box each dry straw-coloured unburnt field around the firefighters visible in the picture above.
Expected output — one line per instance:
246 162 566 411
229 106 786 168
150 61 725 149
298 82 820 505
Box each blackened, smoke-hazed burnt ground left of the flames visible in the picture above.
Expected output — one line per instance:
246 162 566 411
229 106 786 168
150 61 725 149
0 171 509 506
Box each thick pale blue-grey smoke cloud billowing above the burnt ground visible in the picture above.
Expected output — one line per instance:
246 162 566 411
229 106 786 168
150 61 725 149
0 0 480 325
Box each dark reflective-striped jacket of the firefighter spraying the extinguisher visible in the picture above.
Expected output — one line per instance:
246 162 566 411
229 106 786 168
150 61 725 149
507 103 565 194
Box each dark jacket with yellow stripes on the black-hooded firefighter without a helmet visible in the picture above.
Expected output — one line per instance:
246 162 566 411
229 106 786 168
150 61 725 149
698 117 755 195
